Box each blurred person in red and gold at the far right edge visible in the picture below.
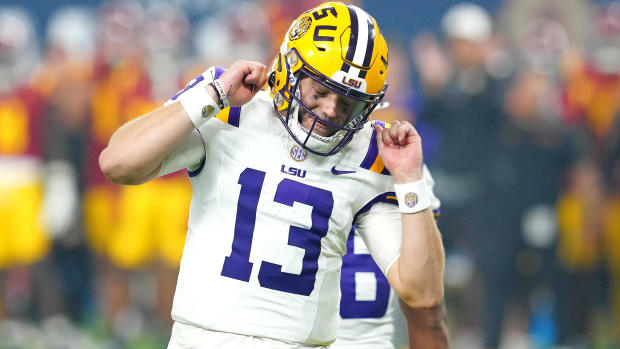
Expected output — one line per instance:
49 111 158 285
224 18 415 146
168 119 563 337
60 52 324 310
559 1 620 342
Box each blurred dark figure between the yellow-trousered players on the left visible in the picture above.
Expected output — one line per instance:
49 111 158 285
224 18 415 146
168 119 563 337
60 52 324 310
38 7 95 322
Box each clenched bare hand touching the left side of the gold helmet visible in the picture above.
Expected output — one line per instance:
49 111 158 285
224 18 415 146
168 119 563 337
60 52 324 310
219 61 267 107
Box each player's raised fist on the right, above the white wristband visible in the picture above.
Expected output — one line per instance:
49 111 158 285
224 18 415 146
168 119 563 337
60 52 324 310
375 121 423 184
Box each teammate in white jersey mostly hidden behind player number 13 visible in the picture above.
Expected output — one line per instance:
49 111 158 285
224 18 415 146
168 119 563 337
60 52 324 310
330 166 449 349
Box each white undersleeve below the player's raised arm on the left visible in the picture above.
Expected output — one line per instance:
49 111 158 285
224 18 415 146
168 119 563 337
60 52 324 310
157 130 207 177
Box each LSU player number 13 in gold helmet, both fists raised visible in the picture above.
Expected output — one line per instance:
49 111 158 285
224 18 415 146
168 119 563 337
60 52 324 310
99 2 444 348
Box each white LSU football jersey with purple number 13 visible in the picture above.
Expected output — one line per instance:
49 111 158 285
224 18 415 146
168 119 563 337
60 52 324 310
164 66 432 345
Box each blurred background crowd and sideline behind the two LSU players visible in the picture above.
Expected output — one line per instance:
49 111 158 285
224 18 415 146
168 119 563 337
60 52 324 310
0 0 620 349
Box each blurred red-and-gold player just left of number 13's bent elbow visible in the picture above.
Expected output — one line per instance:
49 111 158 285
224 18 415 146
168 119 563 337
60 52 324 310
84 1 152 342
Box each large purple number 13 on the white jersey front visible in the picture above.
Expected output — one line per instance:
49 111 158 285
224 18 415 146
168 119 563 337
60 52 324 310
221 168 334 296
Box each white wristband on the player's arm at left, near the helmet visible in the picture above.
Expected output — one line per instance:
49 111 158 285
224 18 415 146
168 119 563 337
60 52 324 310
179 85 220 128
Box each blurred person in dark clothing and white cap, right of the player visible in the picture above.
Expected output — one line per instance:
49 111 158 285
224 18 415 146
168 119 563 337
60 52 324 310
413 3 518 348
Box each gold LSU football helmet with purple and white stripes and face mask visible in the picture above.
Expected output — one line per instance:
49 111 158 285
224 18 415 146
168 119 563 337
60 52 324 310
269 2 388 156
